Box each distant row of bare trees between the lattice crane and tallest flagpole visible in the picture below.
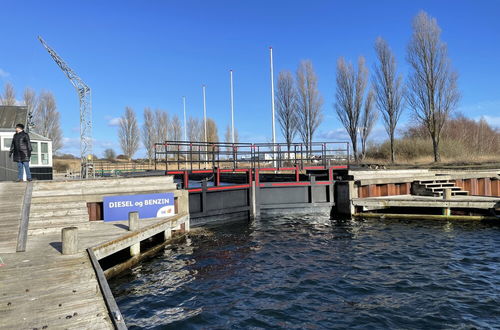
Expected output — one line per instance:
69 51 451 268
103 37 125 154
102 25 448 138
118 107 226 161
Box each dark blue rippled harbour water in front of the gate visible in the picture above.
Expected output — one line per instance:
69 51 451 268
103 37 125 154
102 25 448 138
110 214 500 329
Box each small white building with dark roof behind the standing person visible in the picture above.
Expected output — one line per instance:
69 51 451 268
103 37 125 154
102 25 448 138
0 106 52 181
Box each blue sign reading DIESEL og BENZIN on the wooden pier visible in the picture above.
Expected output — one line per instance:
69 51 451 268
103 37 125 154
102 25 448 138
103 193 175 221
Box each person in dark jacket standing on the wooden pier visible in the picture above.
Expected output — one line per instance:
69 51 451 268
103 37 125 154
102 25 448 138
9 124 32 182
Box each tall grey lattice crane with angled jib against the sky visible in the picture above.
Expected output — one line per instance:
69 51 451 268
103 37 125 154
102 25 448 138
38 36 94 178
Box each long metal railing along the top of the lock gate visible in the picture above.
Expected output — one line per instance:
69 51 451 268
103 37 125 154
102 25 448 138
154 141 350 171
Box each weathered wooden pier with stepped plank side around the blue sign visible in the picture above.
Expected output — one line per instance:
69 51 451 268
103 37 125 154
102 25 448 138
0 176 189 329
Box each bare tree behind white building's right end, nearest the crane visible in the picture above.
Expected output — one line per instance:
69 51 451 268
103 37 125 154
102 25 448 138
33 92 63 153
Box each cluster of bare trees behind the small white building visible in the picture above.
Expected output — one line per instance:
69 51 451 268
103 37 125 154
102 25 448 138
0 83 63 153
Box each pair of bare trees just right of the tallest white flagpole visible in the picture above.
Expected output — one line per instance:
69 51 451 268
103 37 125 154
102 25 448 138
275 60 323 152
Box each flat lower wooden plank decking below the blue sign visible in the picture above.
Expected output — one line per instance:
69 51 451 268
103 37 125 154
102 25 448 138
0 215 186 329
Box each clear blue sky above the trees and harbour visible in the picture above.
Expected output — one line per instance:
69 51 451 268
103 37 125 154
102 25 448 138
0 0 500 155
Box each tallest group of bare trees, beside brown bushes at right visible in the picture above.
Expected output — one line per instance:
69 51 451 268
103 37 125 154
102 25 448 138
335 11 460 162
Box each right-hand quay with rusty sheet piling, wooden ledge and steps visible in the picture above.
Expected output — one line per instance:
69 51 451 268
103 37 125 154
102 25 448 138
335 170 500 220
